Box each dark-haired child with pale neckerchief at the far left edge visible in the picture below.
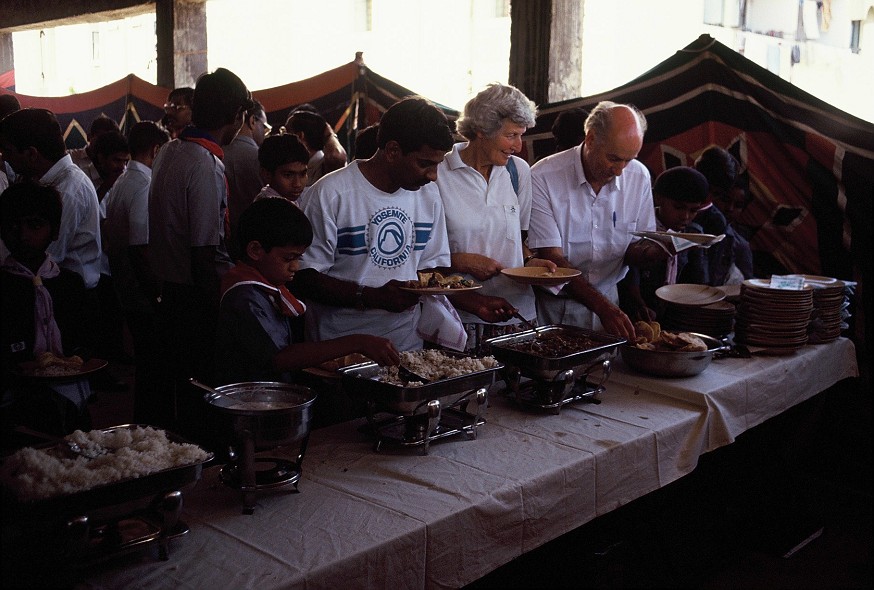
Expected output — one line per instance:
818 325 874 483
0 182 91 442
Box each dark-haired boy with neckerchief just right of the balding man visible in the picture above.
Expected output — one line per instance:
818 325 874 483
620 166 708 321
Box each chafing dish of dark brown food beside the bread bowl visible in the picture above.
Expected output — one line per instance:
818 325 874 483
486 324 625 413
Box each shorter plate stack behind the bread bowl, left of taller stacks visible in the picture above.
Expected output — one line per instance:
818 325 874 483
656 283 735 338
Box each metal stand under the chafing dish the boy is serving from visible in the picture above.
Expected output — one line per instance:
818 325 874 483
359 388 488 455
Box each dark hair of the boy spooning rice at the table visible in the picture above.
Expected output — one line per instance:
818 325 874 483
237 197 313 252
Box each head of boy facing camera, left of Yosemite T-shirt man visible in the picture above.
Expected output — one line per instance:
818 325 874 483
255 133 310 204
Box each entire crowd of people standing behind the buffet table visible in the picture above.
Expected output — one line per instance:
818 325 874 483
0 68 753 456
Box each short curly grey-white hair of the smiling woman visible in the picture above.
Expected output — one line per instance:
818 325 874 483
456 84 537 139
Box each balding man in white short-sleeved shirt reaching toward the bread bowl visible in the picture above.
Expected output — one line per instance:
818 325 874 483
528 101 667 340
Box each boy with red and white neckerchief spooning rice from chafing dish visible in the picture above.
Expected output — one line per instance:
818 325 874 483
216 199 400 390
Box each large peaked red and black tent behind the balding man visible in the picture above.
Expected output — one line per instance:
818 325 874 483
525 35 874 350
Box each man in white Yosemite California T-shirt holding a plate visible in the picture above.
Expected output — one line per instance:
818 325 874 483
293 97 513 350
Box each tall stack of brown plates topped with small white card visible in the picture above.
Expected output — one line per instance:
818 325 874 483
734 279 813 352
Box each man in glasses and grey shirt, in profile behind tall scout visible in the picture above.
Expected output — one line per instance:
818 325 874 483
222 100 271 258
